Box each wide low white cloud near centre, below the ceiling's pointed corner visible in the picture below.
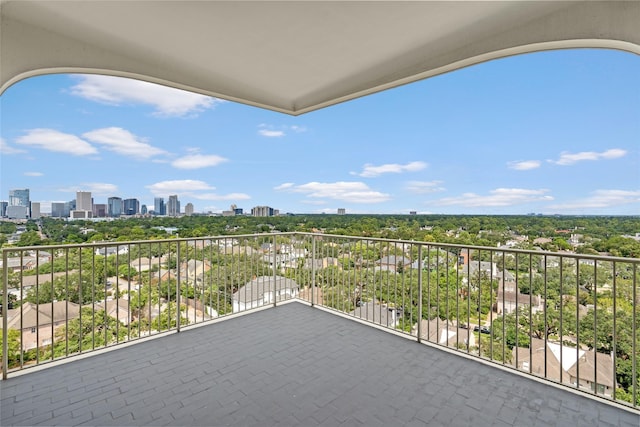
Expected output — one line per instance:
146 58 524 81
276 181 391 203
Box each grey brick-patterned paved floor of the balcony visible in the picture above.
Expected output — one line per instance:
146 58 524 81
0 302 640 427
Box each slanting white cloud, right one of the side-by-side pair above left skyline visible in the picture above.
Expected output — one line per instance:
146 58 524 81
82 127 168 159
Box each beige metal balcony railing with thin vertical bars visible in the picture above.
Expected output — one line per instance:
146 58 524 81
2 233 640 409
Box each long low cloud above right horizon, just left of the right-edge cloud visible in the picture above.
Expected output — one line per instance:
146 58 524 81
435 188 553 207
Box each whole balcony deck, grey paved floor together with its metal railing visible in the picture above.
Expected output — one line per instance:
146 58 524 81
0 233 640 426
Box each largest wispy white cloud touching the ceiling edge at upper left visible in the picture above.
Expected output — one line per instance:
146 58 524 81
71 75 224 117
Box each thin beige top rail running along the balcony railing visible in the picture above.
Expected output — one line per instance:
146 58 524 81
2 231 640 264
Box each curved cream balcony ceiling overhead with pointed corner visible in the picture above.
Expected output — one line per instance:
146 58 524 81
0 0 640 115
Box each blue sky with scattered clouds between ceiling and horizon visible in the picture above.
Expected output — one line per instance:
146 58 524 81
0 49 640 215
